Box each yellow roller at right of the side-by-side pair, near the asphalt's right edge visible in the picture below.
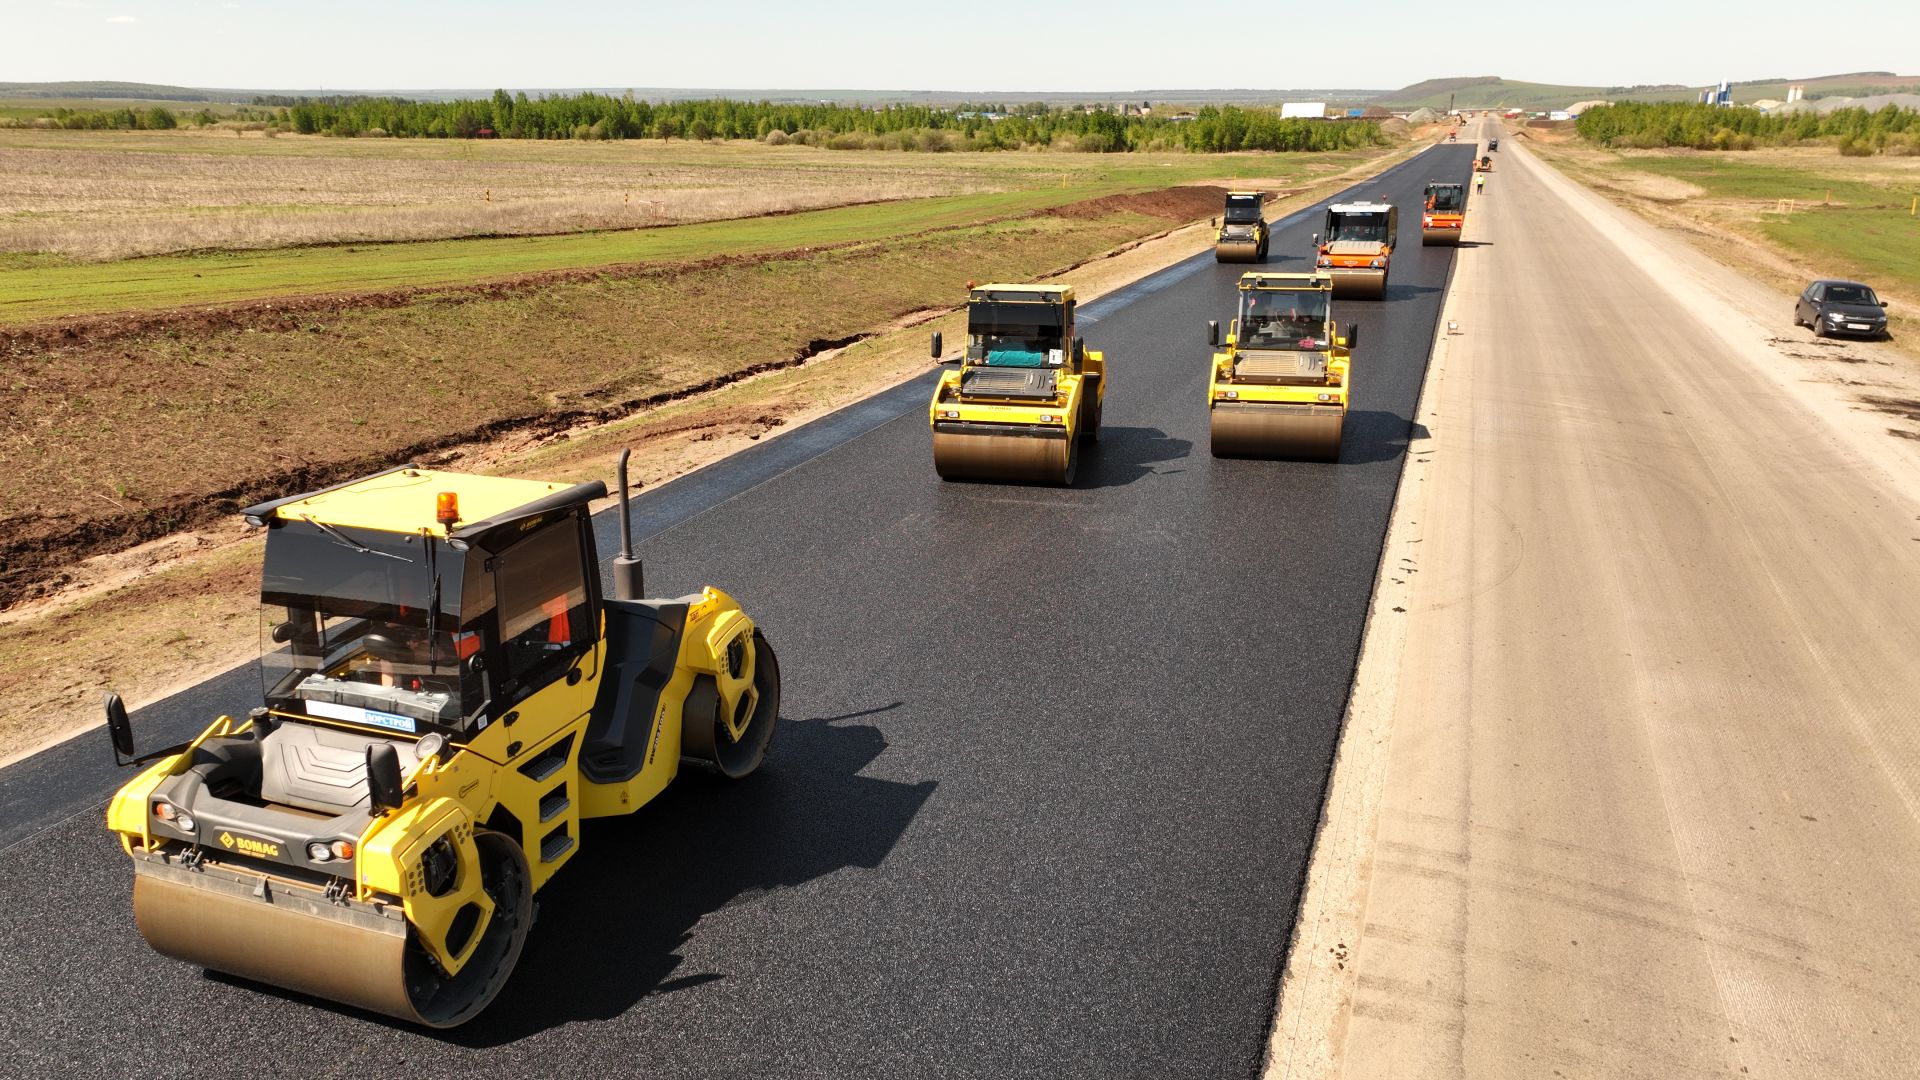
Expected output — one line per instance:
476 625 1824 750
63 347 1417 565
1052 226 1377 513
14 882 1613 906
1206 273 1359 461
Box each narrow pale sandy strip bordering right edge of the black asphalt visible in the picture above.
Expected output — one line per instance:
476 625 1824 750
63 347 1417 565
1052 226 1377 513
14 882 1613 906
1260 145 1463 1080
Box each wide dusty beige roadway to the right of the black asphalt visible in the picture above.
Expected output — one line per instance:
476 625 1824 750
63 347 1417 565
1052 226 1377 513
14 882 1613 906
1269 122 1920 1080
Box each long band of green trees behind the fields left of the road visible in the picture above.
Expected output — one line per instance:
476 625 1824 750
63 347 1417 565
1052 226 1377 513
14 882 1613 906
19 90 1384 154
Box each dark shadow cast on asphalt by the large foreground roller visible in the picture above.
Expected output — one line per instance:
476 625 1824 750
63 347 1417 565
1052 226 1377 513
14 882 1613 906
207 701 939 1049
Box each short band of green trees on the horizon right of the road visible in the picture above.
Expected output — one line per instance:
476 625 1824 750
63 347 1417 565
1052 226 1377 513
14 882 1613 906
1574 102 1920 154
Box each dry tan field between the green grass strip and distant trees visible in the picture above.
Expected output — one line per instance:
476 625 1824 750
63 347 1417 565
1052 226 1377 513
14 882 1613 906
0 129 1351 259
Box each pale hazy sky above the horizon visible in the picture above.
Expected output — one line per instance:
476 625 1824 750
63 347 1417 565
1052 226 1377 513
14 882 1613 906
0 0 1920 90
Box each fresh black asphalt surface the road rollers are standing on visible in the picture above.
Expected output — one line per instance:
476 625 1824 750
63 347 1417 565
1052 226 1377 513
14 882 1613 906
0 146 1473 1078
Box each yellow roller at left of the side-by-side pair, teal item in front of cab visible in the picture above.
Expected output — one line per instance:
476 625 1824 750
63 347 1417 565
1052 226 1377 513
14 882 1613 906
929 284 1106 484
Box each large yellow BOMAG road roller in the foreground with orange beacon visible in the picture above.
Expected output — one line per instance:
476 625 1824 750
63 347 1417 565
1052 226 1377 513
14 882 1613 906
108 455 780 1028
